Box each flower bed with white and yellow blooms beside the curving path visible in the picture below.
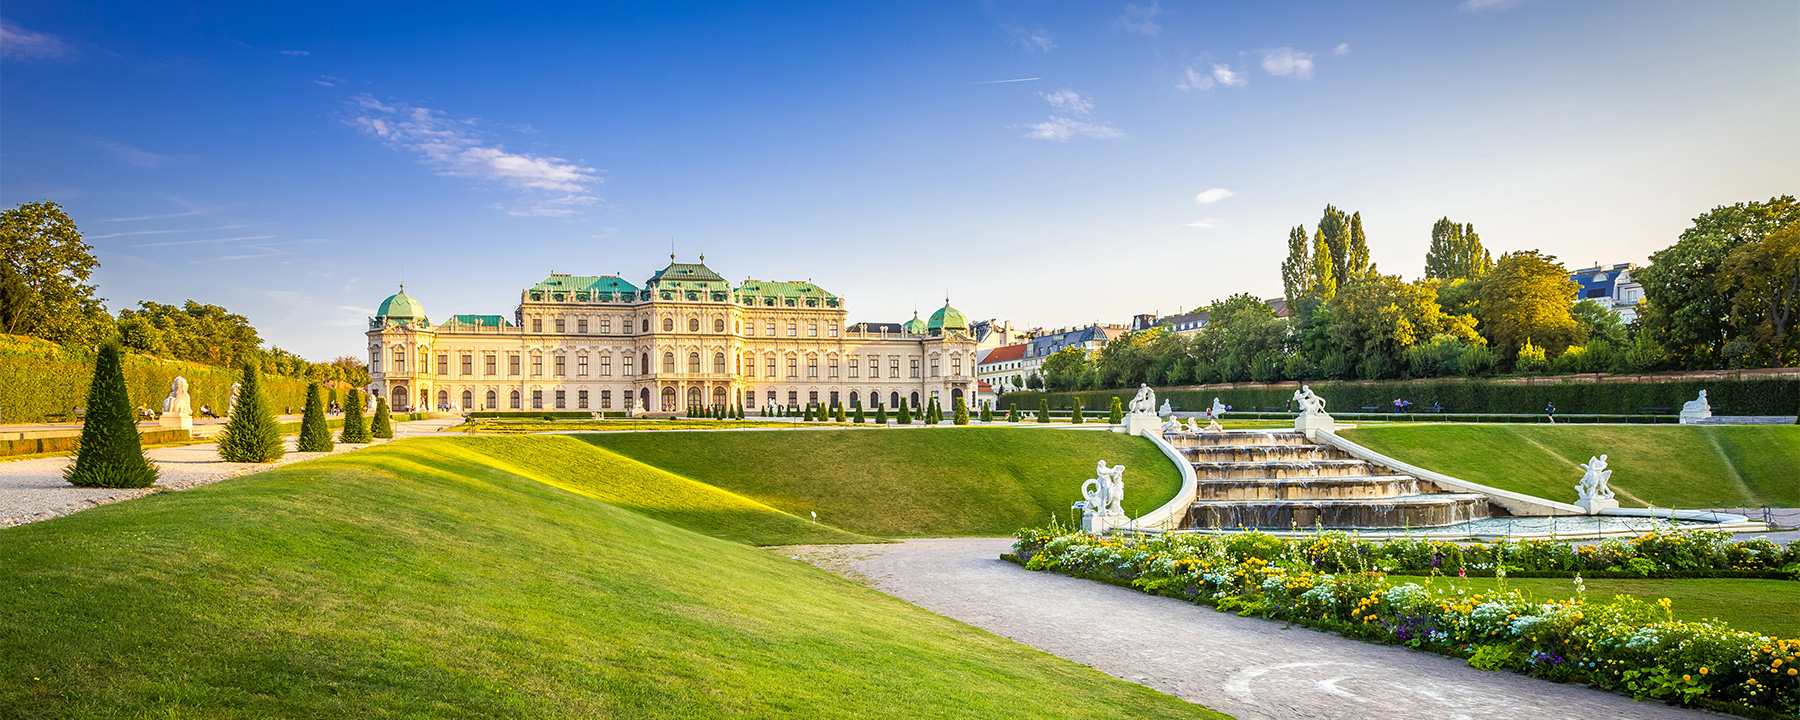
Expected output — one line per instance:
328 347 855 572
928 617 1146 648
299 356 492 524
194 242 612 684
1012 529 1800 716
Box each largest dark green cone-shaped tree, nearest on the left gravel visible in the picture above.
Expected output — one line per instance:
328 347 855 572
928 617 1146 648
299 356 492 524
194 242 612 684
63 338 157 488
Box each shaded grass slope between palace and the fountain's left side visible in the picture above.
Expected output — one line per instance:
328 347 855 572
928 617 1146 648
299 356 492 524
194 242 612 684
576 427 1181 536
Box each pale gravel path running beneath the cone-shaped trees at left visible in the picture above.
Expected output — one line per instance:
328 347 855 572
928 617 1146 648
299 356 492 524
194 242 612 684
0 419 459 527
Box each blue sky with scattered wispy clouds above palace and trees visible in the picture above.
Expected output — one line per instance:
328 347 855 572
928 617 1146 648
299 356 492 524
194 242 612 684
0 0 1800 358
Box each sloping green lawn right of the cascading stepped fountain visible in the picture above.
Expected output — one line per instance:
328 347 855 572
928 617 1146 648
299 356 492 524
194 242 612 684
1343 425 1800 508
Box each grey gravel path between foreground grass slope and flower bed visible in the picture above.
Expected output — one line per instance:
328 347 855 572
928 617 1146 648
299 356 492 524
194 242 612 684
778 538 1721 720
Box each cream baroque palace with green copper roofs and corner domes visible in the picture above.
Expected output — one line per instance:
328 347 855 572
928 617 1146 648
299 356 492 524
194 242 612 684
367 256 976 414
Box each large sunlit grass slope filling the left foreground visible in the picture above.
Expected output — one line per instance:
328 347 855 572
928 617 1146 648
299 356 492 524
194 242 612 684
0 441 1217 718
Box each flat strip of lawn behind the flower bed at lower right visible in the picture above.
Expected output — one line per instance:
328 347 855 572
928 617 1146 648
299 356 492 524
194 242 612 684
1388 576 1800 637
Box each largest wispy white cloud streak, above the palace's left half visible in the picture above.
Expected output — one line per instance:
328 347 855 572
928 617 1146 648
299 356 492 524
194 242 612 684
347 94 601 216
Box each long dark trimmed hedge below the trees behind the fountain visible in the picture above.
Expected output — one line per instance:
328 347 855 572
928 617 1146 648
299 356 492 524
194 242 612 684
999 378 1800 415
